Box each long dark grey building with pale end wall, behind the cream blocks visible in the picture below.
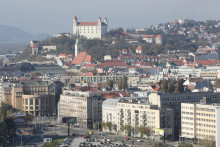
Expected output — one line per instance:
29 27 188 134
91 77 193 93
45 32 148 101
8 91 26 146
149 92 220 138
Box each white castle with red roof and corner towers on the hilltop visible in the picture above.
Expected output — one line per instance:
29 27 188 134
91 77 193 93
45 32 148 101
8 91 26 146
73 16 108 39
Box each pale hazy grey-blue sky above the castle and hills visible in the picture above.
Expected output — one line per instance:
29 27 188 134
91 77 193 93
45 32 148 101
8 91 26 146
0 0 220 35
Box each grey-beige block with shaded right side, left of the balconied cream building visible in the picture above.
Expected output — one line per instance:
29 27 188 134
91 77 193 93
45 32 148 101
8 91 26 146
59 90 105 129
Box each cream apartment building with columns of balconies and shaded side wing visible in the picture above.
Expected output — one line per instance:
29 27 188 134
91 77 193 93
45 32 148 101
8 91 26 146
116 98 174 136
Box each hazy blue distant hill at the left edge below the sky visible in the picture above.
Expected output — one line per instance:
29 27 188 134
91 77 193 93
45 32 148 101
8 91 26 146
0 25 50 44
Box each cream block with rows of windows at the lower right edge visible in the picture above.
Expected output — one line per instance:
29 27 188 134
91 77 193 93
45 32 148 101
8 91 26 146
180 99 220 143
